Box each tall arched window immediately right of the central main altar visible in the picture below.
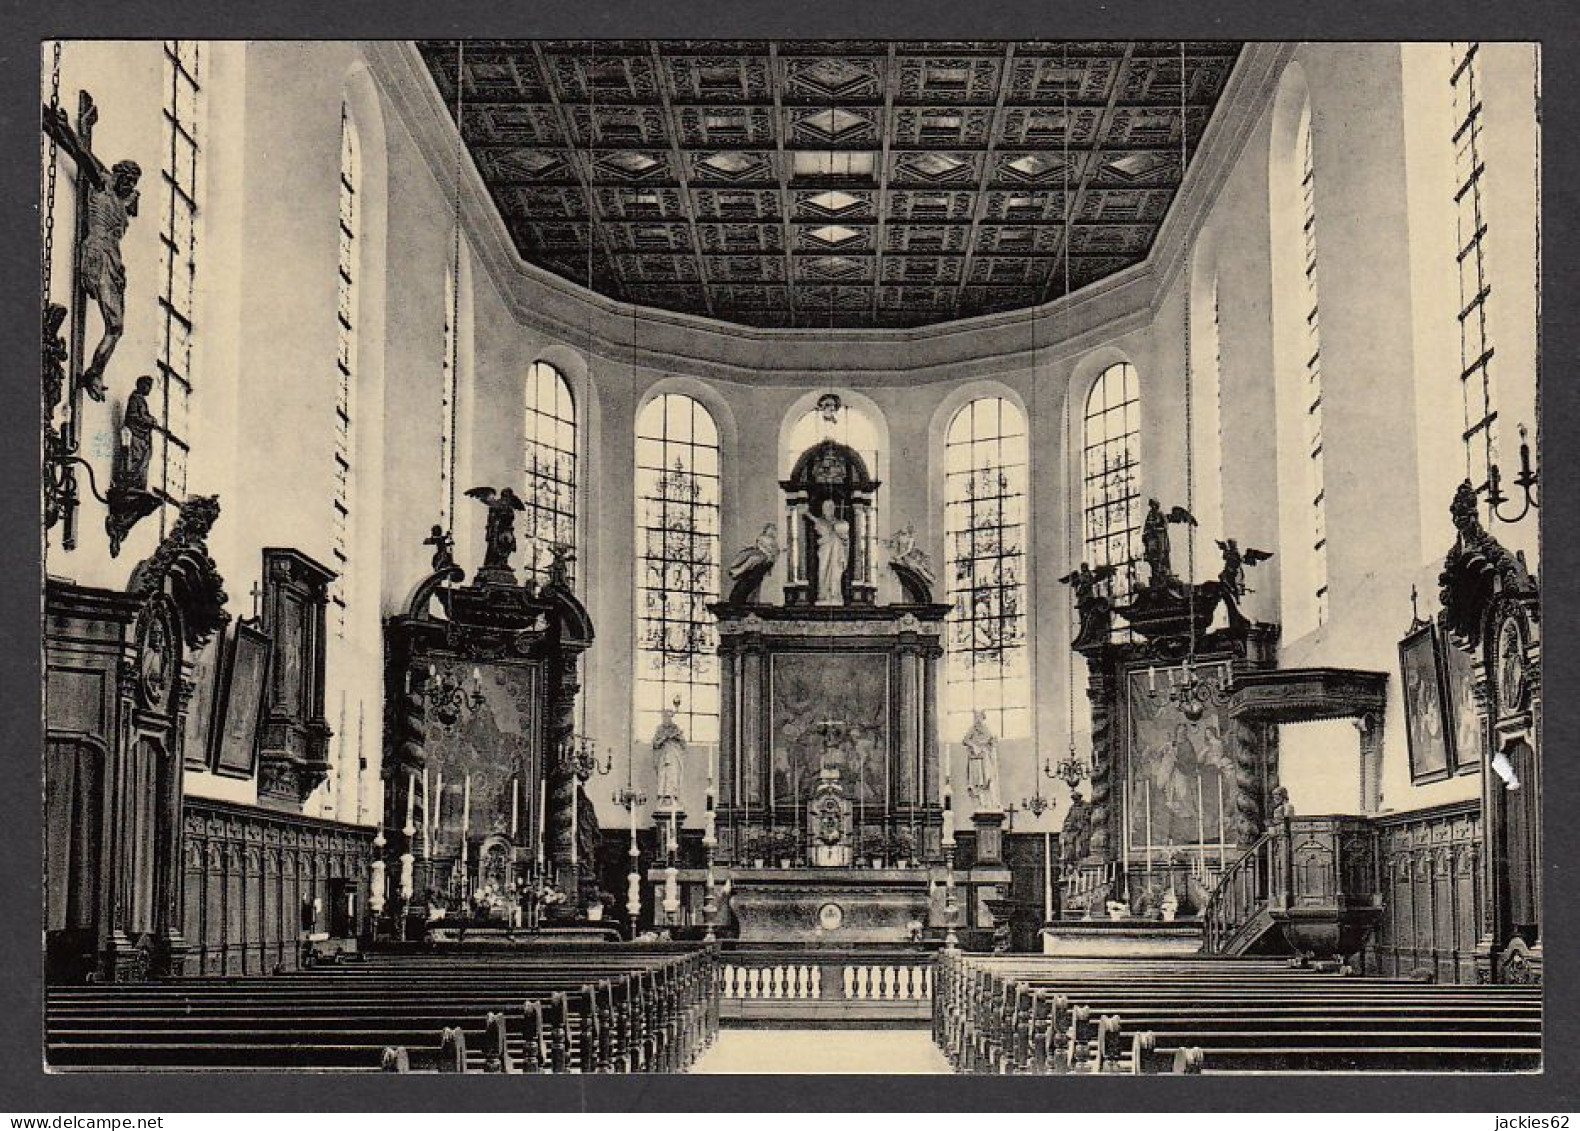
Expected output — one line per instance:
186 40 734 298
943 396 1032 738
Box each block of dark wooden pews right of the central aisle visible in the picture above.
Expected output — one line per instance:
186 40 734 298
934 956 1541 1073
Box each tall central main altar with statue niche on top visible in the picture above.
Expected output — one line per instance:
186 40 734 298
711 420 950 945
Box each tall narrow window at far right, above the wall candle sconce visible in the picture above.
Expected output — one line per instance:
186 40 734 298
1450 43 1498 490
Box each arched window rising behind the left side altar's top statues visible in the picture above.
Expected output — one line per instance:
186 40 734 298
520 362 577 584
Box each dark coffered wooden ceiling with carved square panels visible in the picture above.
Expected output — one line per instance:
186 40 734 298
417 39 1240 327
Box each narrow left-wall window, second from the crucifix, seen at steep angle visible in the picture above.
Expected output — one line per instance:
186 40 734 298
329 106 362 637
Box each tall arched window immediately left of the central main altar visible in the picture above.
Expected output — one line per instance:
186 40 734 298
635 393 719 742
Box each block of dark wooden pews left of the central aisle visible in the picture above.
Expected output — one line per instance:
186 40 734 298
47 948 717 1073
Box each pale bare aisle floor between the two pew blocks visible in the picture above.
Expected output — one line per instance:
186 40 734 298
690 1028 953 1076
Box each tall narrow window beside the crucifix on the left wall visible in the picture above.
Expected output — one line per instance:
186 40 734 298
155 39 202 508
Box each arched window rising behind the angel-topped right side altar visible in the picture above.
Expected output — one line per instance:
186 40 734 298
1081 362 1142 632
